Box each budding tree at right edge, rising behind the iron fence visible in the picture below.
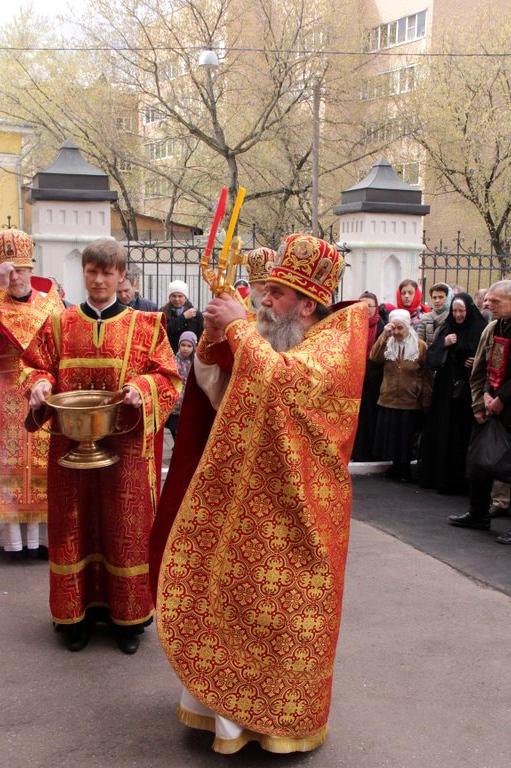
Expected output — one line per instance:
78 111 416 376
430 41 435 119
410 15 511 262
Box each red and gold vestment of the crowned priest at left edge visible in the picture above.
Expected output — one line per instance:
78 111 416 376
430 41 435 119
0 281 63 523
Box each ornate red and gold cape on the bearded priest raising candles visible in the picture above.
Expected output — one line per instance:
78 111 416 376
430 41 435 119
157 304 367 748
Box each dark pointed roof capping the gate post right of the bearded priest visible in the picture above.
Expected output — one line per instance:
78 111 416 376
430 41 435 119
334 158 430 216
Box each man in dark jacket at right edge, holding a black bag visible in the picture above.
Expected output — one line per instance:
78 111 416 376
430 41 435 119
449 280 511 544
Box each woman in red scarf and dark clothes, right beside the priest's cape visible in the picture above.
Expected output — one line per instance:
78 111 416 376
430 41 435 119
351 291 385 461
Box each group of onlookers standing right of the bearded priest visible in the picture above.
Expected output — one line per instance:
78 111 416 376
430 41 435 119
352 280 511 544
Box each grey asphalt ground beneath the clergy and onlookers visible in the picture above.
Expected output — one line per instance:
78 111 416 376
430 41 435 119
0 477 511 768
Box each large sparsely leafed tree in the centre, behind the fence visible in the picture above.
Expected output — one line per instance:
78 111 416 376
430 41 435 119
0 0 392 243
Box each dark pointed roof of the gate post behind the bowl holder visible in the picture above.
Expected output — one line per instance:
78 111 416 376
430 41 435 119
29 139 117 202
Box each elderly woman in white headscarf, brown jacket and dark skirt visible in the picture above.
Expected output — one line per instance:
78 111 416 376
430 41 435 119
370 309 431 482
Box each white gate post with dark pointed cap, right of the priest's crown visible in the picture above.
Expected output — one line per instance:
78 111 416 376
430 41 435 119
334 158 430 303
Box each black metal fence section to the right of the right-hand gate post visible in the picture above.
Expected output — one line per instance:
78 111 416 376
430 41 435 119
420 232 509 295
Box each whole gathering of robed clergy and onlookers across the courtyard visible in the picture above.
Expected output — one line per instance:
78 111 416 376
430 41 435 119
0 224 511 754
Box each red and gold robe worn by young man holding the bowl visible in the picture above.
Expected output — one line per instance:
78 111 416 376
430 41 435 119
24 307 180 625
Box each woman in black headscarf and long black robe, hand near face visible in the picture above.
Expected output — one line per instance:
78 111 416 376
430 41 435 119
419 293 486 493
